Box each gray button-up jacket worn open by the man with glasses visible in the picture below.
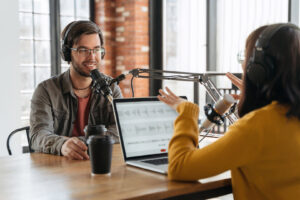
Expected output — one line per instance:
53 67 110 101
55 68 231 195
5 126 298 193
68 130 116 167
30 70 122 155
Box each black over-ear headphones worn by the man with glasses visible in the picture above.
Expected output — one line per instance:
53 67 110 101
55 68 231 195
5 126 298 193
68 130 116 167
61 20 105 62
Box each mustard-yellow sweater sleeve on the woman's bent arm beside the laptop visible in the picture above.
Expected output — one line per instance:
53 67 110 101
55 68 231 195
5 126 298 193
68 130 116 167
168 102 262 181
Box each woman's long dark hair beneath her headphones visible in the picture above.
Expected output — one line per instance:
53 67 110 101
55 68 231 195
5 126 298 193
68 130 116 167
238 26 300 119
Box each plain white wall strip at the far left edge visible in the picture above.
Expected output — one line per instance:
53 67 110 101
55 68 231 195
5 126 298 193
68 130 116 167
0 0 21 156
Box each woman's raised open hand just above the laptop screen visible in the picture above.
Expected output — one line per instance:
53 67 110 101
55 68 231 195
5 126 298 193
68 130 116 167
157 87 186 110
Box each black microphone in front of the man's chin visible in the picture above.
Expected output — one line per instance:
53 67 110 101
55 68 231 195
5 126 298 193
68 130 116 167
90 69 113 103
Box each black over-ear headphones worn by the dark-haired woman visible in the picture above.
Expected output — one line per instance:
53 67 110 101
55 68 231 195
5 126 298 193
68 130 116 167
246 23 298 87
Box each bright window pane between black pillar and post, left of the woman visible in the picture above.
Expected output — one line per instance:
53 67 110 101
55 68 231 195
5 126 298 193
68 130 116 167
163 0 206 112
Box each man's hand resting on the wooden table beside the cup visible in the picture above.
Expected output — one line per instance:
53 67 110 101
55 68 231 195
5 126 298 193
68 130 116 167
61 137 89 160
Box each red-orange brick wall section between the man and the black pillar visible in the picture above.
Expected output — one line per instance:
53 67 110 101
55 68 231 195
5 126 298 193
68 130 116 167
95 0 149 97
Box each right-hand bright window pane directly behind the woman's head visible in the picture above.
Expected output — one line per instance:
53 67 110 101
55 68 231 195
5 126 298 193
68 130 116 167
216 0 288 72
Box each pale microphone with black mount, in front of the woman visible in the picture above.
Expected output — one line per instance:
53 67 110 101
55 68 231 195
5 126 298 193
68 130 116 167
199 94 235 133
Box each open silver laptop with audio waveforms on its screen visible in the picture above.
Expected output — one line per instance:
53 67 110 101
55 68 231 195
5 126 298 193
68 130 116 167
113 97 178 174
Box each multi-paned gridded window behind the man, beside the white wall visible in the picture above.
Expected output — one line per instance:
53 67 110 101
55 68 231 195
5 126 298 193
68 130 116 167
19 0 90 126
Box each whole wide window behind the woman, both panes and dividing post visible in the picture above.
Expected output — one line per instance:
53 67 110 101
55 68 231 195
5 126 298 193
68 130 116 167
163 0 289 114
